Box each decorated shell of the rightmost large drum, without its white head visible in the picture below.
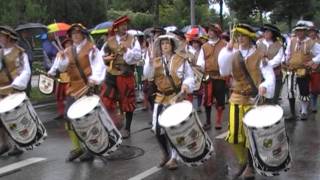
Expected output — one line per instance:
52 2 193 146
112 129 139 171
244 117 291 176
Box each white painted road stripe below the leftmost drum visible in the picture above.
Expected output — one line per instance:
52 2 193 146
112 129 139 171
0 158 46 177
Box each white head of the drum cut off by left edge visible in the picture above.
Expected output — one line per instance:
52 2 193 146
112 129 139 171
0 92 27 113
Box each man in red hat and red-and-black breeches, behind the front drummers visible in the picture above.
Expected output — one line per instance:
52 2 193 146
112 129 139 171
101 16 142 138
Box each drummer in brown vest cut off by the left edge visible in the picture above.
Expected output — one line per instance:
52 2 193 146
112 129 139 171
0 26 31 156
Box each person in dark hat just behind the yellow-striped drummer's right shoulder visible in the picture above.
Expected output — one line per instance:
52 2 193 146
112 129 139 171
257 24 284 104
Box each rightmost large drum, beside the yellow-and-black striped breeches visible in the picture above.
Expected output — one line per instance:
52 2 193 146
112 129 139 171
243 105 291 176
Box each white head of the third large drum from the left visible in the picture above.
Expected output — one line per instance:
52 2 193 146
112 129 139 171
159 101 192 127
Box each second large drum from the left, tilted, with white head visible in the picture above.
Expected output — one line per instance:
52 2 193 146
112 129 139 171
67 95 122 156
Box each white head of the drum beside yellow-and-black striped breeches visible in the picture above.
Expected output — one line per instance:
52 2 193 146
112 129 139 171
243 105 283 128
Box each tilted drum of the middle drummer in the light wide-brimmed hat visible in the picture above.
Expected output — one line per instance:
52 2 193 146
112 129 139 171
159 101 213 166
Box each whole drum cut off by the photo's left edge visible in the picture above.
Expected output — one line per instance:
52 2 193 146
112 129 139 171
0 92 47 150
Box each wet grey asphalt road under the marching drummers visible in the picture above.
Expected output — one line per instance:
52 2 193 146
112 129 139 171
0 89 320 180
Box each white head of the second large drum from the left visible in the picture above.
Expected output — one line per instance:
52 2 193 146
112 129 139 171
67 95 100 119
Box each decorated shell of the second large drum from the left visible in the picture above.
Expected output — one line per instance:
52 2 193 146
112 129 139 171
69 97 122 156
